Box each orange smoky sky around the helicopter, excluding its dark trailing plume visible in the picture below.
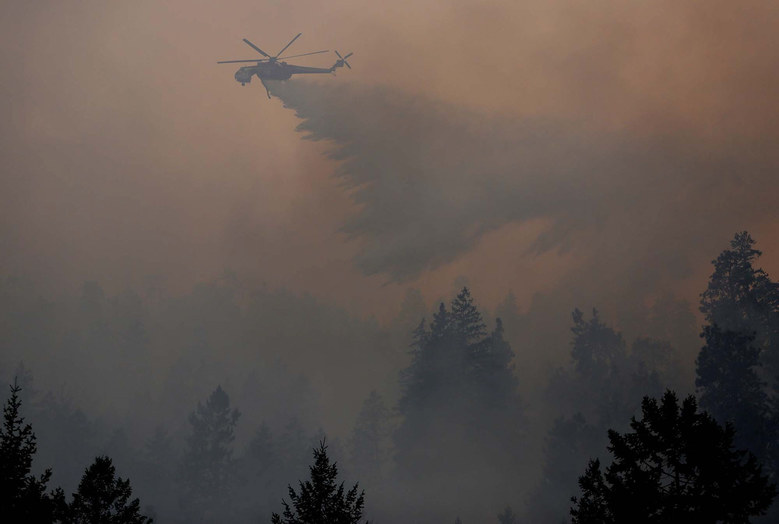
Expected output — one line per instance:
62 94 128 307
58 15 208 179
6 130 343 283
0 0 779 317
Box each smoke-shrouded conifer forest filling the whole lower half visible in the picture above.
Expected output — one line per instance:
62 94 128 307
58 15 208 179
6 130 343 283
0 231 779 524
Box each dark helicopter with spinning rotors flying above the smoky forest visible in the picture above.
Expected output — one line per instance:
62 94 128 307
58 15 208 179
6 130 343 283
217 33 354 98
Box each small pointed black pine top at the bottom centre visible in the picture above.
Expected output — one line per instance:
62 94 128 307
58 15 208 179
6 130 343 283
271 441 365 524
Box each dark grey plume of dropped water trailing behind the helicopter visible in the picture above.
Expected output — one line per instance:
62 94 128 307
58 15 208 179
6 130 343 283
275 82 779 292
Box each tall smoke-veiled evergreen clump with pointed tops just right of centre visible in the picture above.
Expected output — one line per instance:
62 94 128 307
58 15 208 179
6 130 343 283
394 288 524 518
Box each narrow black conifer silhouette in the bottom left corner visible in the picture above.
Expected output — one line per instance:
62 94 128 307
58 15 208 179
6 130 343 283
0 381 64 522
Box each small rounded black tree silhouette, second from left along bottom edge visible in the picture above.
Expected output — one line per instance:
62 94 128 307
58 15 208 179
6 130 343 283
66 457 152 524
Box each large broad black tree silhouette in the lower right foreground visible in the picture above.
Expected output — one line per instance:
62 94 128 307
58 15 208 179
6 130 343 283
571 391 776 524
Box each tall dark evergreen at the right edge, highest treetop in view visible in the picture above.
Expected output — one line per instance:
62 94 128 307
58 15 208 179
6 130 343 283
695 231 779 474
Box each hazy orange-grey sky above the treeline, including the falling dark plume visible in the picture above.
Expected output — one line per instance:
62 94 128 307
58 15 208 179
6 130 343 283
0 0 779 316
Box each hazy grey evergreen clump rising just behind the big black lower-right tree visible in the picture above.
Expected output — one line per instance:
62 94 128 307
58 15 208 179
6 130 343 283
526 309 671 522
